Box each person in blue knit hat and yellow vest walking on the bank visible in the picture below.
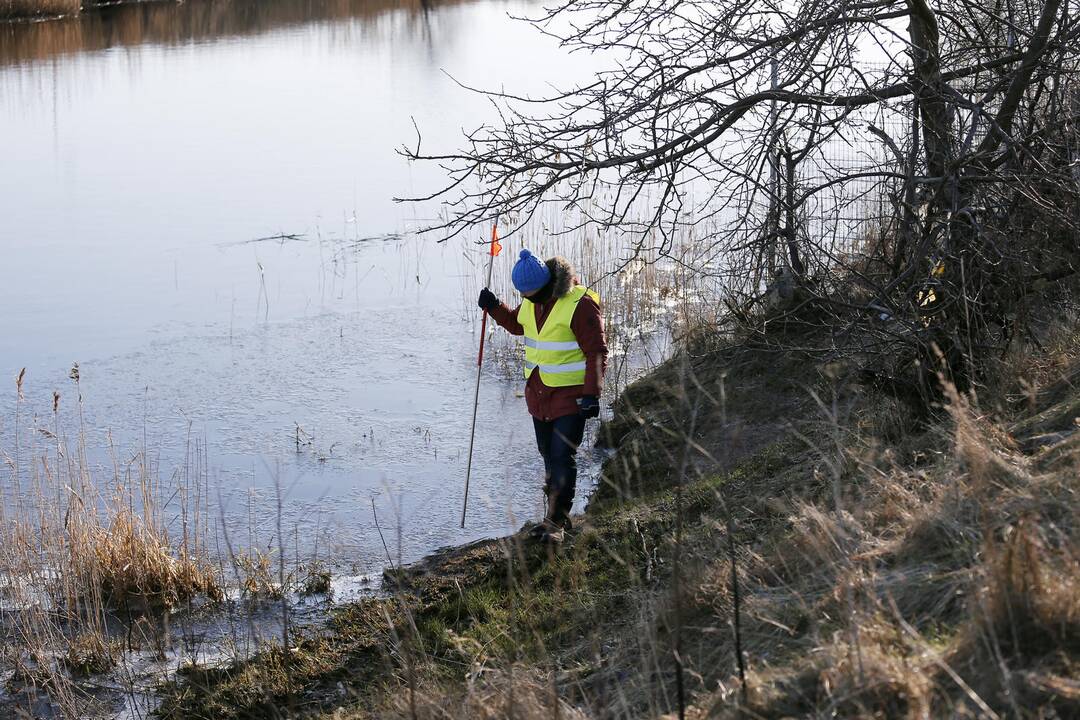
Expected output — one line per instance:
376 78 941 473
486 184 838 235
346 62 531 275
477 249 608 543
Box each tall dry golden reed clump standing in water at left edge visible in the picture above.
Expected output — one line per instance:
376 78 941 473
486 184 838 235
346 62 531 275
0 375 222 617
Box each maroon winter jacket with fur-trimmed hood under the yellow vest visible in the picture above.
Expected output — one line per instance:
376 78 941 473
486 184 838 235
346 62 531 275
490 261 607 422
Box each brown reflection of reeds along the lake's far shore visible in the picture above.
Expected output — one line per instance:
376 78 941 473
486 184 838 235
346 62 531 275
0 0 473 66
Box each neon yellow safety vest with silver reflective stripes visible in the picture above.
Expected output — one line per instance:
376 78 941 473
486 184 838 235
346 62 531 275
517 285 600 388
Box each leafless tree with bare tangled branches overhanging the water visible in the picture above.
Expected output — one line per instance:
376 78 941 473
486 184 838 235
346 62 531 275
403 0 1080 403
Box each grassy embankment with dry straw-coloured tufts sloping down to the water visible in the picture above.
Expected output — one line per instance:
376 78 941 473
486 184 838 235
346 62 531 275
161 317 1080 720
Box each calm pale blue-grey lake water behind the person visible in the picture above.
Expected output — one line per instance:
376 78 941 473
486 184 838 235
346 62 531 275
0 0 617 572
